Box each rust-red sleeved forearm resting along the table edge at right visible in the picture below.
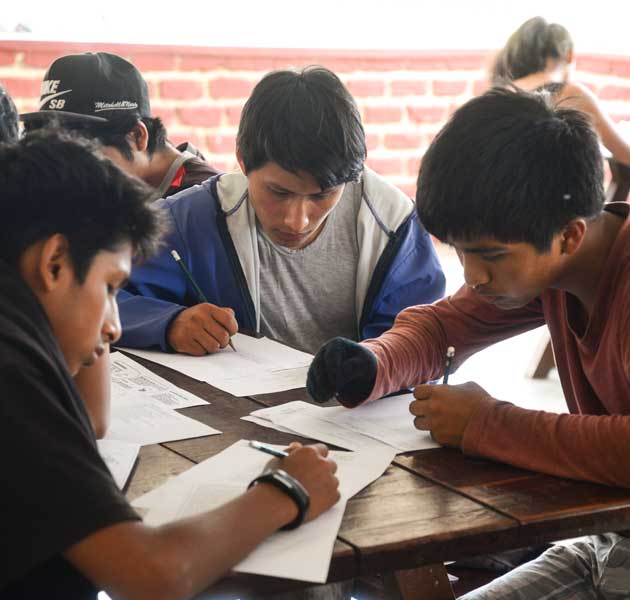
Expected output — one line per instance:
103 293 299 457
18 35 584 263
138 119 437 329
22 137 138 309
462 402 630 488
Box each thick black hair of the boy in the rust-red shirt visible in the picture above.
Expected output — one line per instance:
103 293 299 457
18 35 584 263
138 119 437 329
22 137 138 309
416 88 604 252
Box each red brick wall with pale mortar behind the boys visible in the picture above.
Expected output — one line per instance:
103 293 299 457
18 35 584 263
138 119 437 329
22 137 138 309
0 41 630 195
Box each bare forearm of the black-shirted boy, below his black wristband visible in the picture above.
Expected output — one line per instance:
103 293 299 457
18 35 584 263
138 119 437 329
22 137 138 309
66 485 297 600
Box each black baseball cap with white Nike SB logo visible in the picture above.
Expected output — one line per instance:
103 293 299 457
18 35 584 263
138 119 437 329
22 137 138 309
20 52 151 122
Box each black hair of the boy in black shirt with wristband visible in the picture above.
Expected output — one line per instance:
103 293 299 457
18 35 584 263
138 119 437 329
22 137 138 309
0 128 162 282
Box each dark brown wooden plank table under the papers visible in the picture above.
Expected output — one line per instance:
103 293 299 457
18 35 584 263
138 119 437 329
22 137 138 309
128 357 630 600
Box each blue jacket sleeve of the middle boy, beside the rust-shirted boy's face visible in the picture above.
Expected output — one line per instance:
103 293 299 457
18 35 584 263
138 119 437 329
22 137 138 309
361 212 446 339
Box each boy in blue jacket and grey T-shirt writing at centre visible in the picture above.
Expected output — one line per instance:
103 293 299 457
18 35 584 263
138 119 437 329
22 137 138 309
119 66 444 355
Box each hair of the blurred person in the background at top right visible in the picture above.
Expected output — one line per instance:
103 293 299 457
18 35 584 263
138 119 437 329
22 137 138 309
491 17 573 84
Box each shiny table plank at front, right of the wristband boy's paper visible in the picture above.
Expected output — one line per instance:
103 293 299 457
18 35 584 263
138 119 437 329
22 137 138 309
339 466 518 574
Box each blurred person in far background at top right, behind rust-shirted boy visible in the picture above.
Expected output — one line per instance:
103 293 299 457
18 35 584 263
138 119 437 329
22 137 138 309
491 17 630 165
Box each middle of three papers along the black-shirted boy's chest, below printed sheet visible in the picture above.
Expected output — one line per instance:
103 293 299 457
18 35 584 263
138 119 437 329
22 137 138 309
105 396 221 446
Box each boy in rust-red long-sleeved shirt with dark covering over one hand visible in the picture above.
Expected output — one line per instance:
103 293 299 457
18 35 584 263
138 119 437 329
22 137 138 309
308 90 630 599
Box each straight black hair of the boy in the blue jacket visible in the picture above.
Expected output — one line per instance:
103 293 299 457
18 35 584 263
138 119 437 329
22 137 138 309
236 66 367 189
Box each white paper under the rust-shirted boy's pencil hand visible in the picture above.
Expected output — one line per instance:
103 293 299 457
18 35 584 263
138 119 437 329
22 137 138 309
248 394 438 452
